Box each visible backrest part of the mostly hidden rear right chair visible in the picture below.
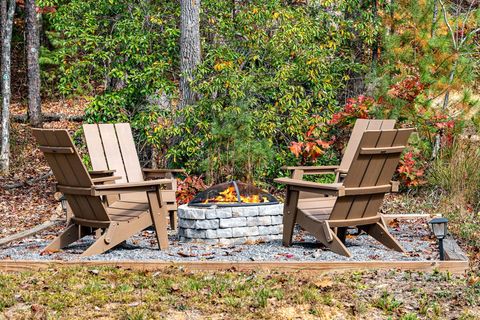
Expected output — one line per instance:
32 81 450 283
339 119 395 172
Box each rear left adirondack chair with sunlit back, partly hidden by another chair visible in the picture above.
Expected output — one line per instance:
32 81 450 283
83 123 185 230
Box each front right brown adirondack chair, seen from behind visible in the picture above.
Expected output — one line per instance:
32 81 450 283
275 129 413 257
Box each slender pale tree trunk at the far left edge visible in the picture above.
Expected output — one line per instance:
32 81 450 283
0 0 16 173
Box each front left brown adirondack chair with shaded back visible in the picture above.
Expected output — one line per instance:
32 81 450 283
33 129 171 256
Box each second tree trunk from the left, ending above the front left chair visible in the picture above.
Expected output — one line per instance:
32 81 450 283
25 0 43 128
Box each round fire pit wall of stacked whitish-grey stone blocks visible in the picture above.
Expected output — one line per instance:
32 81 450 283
178 203 283 245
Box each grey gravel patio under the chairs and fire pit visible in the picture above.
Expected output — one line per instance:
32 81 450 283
0 219 438 262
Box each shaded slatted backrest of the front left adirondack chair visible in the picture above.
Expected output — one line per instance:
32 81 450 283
32 129 110 221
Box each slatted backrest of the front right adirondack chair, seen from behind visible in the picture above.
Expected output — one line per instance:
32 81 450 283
330 129 414 220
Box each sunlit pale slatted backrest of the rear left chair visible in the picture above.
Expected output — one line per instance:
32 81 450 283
83 123 144 183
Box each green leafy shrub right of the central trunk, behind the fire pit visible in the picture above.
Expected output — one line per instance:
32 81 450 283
161 1 378 181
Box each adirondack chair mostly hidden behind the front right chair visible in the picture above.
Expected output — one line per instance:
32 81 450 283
283 119 396 182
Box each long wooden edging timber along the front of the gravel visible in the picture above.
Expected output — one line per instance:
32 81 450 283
0 260 469 274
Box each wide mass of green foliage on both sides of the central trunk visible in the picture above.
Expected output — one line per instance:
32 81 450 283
40 0 380 182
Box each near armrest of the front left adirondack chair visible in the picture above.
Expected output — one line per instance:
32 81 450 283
91 179 172 196
